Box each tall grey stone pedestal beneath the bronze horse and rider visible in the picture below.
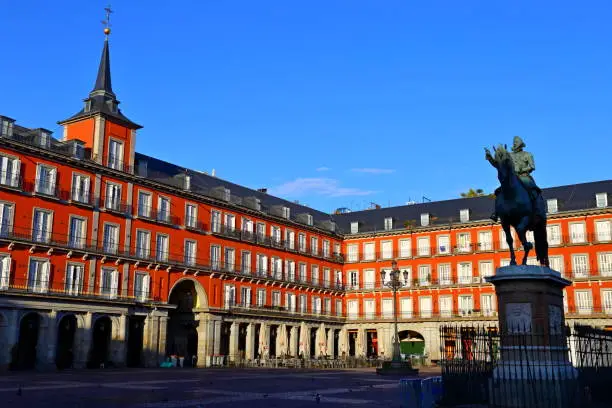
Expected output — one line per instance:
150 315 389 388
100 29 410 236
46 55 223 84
487 265 579 408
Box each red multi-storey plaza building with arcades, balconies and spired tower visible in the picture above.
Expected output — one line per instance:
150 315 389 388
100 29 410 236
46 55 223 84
0 33 612 369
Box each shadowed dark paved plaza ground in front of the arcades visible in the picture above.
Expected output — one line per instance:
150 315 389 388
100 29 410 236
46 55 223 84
0 369 437 408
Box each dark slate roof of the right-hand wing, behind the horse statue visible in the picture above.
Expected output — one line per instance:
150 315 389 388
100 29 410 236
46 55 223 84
335 180 612 234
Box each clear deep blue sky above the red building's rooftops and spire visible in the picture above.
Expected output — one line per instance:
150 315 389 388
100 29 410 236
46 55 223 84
0 0 612 211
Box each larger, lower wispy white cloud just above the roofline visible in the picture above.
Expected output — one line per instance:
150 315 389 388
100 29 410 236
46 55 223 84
270 177 376 197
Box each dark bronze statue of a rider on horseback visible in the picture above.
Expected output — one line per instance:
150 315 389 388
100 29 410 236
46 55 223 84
485 136 549 266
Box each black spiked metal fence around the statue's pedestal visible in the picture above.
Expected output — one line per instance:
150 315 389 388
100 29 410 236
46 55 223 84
440 325 612 408
